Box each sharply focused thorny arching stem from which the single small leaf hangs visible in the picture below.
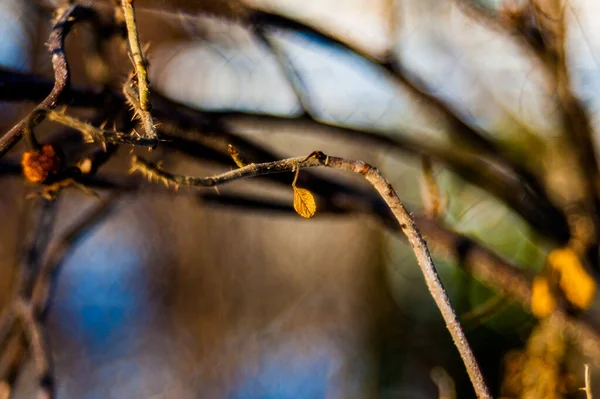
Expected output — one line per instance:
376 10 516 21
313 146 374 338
132 151 492 399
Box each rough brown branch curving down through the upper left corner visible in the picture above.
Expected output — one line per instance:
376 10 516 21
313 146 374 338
0 4 97 158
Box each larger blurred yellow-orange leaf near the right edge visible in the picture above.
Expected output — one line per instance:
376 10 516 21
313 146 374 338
548 248 596 309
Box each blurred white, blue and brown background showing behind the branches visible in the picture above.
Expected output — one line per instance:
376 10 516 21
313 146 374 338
0 0 600 399
